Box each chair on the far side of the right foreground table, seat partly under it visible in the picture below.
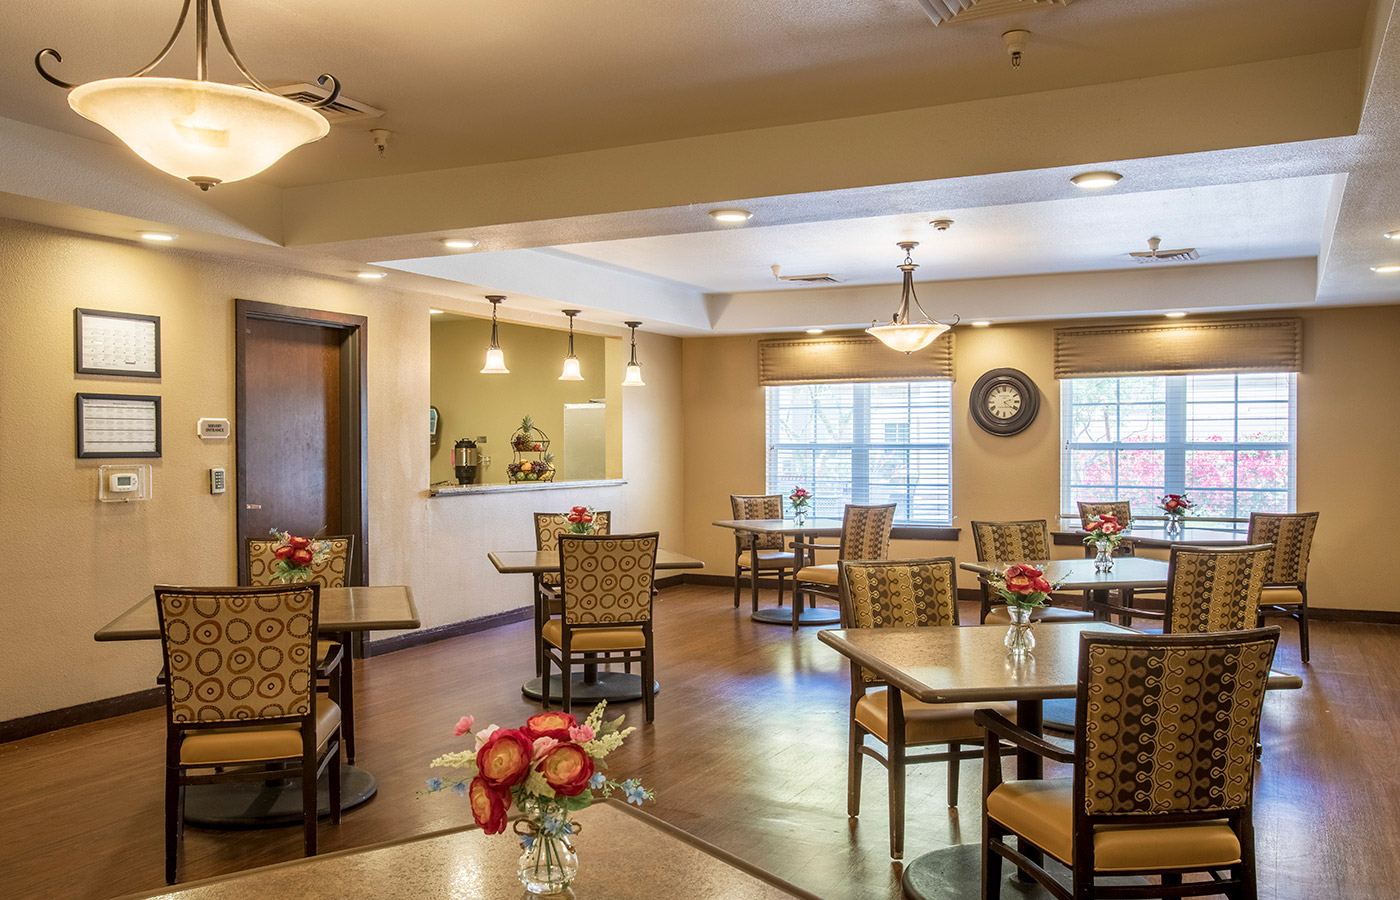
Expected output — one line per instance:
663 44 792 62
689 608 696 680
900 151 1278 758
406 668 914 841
837 557 1011 859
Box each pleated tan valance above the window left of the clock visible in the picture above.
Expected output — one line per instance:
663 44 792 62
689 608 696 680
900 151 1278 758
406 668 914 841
759 335 953 386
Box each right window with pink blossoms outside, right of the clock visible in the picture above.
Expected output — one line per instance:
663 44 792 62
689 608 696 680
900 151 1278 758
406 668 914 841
1060 372 1298 518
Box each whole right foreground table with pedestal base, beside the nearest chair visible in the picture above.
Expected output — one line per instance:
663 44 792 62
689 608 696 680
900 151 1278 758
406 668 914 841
818 621 1303 900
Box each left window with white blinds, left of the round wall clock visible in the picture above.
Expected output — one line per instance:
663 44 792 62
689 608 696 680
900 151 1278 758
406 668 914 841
764 381 952 525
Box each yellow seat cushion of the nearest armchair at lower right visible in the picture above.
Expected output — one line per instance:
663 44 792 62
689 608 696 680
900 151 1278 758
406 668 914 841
987 778 1239 872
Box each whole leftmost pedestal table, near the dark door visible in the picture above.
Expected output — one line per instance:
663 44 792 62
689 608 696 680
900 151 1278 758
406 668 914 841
92 585 423 829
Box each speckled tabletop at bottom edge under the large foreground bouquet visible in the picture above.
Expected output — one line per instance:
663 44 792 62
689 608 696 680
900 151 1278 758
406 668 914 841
126 795 818 900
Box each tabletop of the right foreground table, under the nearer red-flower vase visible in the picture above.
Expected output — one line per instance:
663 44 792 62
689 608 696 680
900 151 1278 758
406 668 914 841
818 621 1302 703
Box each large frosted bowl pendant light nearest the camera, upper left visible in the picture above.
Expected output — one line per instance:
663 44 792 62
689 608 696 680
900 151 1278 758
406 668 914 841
34 0 340 190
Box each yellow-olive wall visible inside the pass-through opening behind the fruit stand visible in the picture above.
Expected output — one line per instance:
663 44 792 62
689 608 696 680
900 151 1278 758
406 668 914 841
431 316 610 484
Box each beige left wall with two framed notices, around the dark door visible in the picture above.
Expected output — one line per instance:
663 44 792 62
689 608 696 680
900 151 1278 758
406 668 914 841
0 220 680 721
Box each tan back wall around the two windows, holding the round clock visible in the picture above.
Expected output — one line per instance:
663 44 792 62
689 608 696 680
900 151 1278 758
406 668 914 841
683 307 1400 610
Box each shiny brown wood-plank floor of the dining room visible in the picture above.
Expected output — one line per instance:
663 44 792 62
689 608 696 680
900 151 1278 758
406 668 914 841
0 585 1400 900
